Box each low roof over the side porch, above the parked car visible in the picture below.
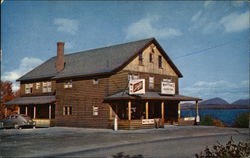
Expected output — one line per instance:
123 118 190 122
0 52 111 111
5 96 56 105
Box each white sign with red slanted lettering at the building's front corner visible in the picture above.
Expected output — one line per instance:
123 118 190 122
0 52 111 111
129 79 145 94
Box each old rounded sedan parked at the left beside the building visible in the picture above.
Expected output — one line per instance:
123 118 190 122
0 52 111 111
0 114 36 129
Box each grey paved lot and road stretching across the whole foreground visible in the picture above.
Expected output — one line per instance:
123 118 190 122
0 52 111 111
0 126 249 157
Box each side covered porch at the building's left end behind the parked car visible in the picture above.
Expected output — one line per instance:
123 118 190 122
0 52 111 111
5 96 56 127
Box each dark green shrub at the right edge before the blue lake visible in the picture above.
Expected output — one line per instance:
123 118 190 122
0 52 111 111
233 112 250 128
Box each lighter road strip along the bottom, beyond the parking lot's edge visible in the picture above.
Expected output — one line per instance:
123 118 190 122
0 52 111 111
63 134 246 158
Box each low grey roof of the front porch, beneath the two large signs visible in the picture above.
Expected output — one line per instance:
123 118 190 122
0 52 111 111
104 92 202 101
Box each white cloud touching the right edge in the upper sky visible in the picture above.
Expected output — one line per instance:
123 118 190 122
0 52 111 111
220 11 249 32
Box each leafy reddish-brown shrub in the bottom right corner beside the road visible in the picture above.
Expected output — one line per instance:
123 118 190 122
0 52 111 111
195 137 250 158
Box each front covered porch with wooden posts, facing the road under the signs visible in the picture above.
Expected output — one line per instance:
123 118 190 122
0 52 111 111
105 92 201 129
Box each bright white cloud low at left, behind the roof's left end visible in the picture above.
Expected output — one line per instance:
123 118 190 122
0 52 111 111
1 57 43 91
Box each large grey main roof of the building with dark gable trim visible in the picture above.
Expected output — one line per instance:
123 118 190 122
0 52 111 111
18 38 182 81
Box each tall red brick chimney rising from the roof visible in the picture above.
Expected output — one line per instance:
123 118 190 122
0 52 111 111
56 42 64 72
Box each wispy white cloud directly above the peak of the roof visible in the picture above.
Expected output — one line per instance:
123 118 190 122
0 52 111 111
126 16 182 38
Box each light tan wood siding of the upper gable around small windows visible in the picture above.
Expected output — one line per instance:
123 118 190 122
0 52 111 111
123 44 178 77
